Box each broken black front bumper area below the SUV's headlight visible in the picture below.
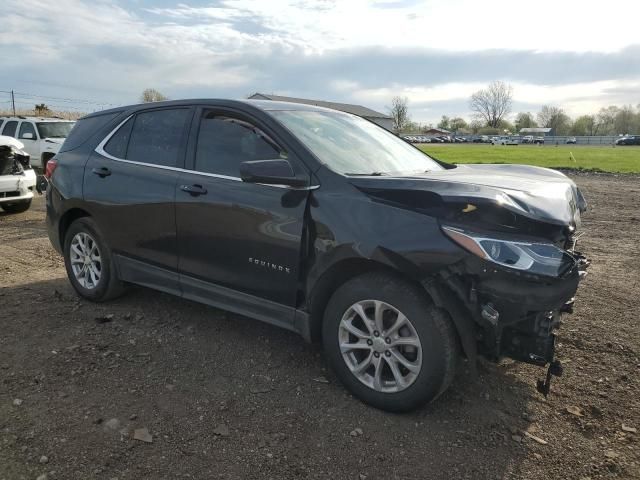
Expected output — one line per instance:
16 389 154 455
445 248 588 366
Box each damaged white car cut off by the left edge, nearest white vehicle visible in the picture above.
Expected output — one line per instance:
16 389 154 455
0 135 36 213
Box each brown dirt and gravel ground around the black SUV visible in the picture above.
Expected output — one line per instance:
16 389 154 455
0 174 640 480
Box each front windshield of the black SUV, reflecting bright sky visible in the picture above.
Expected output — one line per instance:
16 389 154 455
270 110 443 175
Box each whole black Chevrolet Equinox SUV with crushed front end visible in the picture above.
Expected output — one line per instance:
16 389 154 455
46 100 586 411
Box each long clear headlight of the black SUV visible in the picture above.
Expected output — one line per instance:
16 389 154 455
442 226 575 277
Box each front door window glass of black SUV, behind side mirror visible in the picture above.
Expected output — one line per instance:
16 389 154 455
195 112 282 177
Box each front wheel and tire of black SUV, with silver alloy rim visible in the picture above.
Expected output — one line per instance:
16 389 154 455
322 273 459 412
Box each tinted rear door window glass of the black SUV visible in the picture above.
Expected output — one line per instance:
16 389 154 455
125 108 190 167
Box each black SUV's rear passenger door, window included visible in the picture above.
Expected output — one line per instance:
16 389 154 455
84 107 193 292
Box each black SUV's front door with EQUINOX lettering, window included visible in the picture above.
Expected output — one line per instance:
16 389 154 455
176 109 309 307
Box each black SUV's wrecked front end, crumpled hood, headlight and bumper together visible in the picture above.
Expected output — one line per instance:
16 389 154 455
356 165 589 395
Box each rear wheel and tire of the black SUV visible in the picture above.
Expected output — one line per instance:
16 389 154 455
63 217 125 302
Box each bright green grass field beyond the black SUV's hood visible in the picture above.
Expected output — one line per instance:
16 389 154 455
419 144 640 173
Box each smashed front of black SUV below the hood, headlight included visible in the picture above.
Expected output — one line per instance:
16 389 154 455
440 196 589 396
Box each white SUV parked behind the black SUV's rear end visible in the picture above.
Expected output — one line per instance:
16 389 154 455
0 117 76 170
